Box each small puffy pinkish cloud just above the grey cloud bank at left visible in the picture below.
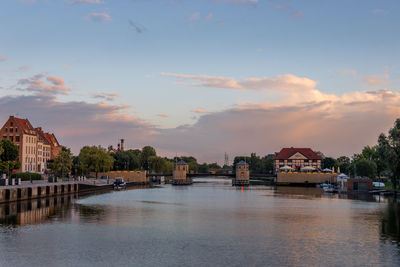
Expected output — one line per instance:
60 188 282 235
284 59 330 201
16 74 71 96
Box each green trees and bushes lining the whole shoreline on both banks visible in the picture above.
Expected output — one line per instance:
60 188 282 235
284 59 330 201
0 118 400 191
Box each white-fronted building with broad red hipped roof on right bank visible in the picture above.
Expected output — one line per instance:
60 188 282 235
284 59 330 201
275 147 322 173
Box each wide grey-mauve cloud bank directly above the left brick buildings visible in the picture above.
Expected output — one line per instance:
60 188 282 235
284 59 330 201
0 95 156 153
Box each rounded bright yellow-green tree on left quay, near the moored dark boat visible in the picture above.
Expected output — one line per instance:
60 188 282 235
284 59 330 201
79 146 114 178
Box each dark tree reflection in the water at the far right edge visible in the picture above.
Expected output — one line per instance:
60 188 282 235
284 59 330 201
381 199 400 242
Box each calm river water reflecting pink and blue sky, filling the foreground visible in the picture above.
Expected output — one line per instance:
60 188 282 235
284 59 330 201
0 179 400 267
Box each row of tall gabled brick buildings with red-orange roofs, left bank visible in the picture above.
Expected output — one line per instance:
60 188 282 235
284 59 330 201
0 116 61 172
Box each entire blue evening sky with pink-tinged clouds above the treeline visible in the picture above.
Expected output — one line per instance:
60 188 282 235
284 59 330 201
0 0 400 163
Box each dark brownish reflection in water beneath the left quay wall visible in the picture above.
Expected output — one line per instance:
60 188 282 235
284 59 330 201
0 195 74 225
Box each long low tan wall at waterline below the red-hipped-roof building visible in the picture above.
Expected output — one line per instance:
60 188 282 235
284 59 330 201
276 172 337 184
